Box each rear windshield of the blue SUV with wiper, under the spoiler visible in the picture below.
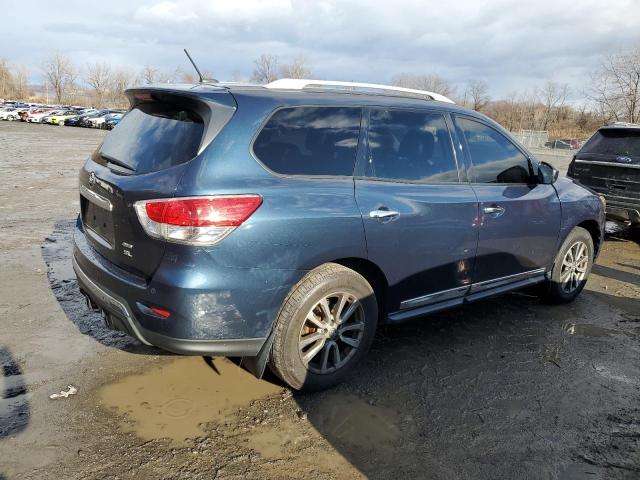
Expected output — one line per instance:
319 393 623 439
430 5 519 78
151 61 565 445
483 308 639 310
99 103 204 173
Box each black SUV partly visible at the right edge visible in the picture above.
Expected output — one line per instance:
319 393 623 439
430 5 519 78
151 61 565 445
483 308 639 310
567 123 640 226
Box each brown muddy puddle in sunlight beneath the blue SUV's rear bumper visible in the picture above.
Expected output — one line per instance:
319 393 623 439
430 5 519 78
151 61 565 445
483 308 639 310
99 357 282 444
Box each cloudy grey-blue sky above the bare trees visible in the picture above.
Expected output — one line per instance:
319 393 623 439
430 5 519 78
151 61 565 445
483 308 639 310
0 0 640 100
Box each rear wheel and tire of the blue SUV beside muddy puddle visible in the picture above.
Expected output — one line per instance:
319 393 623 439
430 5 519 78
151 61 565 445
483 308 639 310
269 263 378 390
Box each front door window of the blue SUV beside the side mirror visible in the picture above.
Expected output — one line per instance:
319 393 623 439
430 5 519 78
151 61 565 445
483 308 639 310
456 118 531 183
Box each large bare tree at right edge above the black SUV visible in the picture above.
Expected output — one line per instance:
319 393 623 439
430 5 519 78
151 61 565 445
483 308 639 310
587 48 640 123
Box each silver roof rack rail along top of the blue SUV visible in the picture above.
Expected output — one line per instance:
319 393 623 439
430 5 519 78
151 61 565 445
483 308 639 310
265 78 455 103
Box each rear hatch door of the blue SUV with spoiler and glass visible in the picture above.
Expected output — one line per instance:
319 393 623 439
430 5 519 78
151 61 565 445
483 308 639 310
79 87 235 279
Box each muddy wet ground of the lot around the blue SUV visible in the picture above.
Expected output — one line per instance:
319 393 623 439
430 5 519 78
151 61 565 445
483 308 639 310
0 122 640 479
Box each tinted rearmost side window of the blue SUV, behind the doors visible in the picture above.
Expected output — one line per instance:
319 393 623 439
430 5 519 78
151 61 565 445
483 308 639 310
253 107 361 176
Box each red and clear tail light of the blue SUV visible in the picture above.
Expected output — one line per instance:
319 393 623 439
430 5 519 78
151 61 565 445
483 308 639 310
134 195 262 245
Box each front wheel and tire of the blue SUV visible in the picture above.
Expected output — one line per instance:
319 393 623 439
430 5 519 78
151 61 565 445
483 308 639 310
541 227 594 304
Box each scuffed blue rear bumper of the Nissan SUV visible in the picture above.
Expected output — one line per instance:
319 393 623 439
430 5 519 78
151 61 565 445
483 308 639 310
73 218 304 357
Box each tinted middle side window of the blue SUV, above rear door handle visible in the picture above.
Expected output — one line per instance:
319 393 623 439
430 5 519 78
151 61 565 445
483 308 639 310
366 110 458 183
